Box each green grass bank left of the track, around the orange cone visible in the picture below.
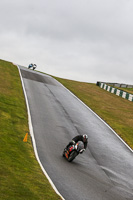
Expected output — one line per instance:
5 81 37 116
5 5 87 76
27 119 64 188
0 60 60 200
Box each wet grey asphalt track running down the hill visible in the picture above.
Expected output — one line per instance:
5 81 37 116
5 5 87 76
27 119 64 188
20 67 133 200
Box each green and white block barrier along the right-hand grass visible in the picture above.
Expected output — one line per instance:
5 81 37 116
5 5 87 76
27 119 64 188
97 82 133 101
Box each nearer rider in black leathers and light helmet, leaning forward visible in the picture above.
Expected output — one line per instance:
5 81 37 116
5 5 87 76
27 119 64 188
65 134 88 151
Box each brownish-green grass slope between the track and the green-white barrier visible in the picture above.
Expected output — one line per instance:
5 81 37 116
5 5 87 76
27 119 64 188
54 77 133 149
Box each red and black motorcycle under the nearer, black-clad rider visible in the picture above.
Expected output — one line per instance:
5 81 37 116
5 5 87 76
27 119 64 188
63 141 85 162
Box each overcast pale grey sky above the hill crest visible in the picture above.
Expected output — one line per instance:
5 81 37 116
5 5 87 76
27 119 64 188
0 0 133 84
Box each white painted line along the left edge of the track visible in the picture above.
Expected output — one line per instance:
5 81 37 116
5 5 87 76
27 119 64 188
17 65 65 200
